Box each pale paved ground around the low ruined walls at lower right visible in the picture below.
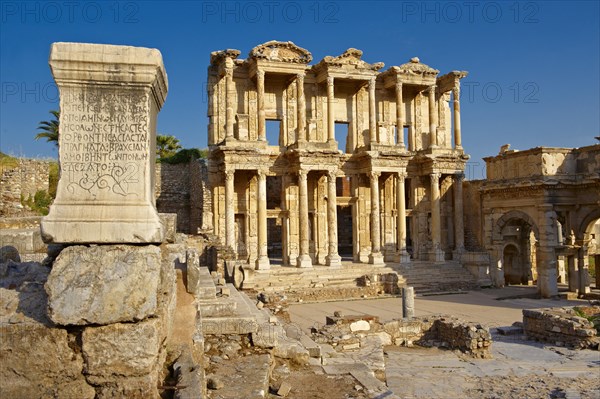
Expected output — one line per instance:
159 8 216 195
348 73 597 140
289 287 600 399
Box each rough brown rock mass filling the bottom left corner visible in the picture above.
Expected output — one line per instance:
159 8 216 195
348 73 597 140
0 262 95 399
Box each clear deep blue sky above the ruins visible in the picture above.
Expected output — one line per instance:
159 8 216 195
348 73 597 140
0 0 600 179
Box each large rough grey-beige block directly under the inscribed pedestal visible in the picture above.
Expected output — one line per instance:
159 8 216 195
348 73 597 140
46 245 161 325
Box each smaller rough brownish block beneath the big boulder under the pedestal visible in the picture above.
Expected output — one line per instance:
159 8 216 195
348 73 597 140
82 318 161 384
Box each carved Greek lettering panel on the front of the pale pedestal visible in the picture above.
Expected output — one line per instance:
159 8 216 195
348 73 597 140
60 88 151 198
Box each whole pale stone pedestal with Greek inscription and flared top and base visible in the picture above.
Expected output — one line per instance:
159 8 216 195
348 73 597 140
41 43 167 243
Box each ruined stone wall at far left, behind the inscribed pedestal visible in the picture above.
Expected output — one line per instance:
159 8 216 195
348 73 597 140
0 158 50 216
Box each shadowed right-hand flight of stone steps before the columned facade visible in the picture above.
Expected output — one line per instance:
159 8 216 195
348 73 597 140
390 261 479 295
